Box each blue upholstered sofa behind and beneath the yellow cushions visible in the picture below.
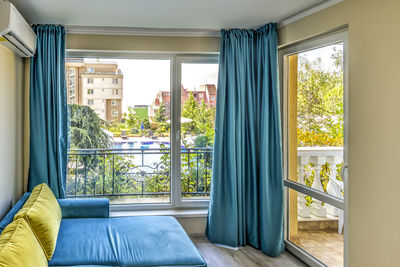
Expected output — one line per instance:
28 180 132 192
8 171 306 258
0 193 207 266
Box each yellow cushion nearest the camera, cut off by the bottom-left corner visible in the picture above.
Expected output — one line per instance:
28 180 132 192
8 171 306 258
0 219 47 267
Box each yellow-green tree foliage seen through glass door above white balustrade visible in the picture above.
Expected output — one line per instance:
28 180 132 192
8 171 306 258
297 48 343 147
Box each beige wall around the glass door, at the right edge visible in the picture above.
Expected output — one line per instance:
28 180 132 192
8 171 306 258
279 0 400 267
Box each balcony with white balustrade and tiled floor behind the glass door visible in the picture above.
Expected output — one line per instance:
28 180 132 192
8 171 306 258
289 147 344 266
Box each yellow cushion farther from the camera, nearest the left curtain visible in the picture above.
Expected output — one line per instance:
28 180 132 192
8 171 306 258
14 184 61 260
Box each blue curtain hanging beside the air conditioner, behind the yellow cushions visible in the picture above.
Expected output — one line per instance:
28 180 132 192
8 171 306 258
28 25 68 198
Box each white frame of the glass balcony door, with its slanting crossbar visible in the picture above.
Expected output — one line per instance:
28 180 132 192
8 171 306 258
278 26 349 267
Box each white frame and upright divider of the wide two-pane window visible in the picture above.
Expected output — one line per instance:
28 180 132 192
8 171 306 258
66 49 219 212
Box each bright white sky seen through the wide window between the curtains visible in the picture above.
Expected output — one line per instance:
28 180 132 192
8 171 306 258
87 58 218 112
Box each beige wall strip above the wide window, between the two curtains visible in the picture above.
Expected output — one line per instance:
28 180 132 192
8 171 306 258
66 34 220 52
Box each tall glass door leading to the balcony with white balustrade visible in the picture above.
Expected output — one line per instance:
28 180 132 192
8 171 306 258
280 33 347 266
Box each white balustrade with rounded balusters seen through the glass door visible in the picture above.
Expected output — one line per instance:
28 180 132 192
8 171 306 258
297 147 343 218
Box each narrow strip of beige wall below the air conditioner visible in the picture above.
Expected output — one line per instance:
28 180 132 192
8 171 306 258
0 45 24 218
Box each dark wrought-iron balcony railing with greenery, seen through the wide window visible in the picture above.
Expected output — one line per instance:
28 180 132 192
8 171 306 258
66 148 212 204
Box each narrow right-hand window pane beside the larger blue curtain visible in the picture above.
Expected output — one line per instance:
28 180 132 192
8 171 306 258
180 59 218 202
